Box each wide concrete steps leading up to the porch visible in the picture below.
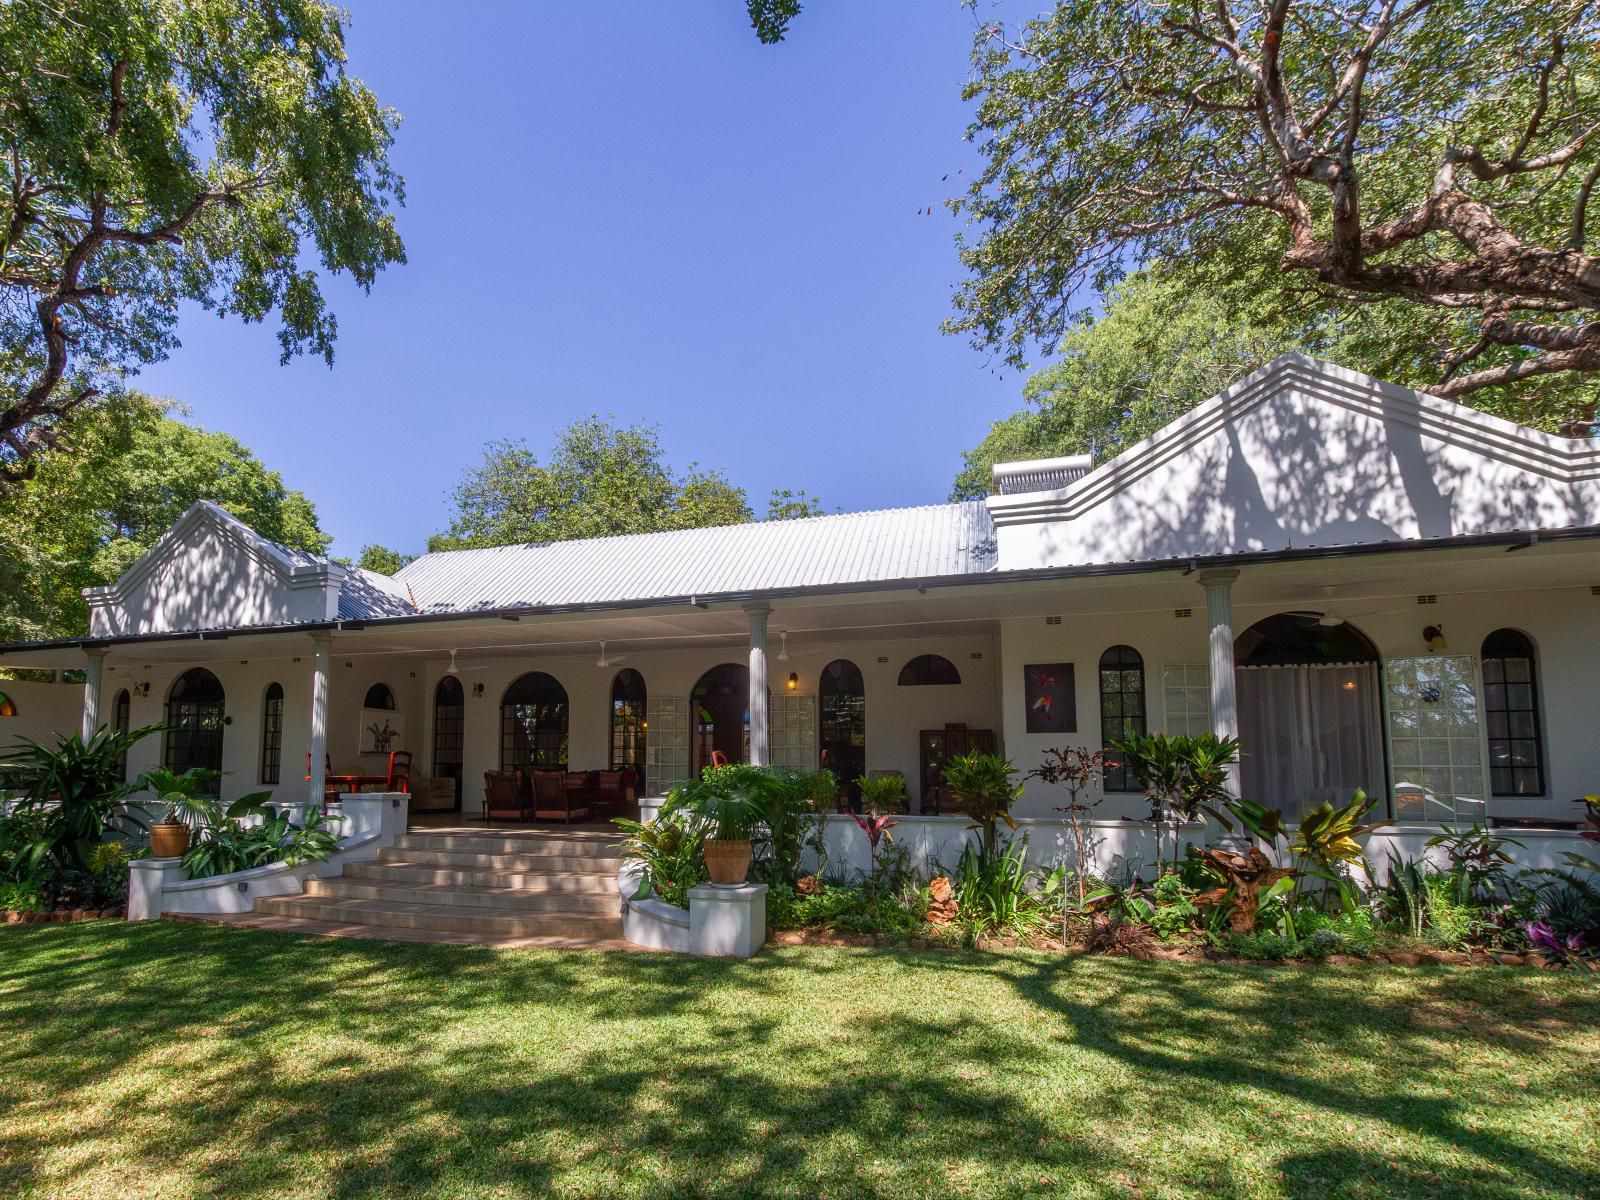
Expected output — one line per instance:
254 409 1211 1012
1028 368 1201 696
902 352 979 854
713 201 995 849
229 830 624 949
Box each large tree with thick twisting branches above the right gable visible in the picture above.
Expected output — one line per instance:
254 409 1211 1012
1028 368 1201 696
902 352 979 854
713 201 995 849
949 0 1600 432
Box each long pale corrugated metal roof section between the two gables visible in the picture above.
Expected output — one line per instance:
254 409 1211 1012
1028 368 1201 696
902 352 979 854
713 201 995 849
395 501 995 613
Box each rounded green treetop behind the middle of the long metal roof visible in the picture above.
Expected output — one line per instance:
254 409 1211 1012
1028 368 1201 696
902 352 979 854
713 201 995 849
427 416 750 550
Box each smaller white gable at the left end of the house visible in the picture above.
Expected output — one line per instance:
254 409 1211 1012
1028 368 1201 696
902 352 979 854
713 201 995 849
83 501 346 637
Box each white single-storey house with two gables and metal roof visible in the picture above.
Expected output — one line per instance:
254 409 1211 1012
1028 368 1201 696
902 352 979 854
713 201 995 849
0 355 1600 824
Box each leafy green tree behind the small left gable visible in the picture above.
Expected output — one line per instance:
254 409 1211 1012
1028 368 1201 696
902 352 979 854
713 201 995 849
0 392 330 640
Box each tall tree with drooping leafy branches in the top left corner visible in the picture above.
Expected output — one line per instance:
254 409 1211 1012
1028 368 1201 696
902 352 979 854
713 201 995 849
0 0 403 490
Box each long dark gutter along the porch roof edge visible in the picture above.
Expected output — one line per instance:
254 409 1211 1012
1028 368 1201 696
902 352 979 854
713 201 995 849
9 525 1600 658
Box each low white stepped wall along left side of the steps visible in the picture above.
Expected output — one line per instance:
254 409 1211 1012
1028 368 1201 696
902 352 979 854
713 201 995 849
128 792 410 922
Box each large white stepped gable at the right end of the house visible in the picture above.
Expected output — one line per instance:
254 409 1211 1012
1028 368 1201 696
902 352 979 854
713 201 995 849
987 355 1600 571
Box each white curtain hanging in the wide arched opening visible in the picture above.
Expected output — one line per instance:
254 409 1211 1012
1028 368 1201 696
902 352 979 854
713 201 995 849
1237 662 1384 821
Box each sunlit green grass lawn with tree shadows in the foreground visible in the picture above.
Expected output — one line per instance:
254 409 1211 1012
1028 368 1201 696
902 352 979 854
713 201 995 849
0 922 1600 1198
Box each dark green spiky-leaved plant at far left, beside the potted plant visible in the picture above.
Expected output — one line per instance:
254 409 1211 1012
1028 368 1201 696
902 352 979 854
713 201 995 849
5 725 162 878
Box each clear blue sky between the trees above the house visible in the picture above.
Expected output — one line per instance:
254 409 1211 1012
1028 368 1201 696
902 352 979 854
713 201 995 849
134 0 1021 554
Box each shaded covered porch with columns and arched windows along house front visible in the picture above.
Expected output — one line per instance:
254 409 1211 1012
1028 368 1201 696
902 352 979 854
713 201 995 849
0 539 1600 830
